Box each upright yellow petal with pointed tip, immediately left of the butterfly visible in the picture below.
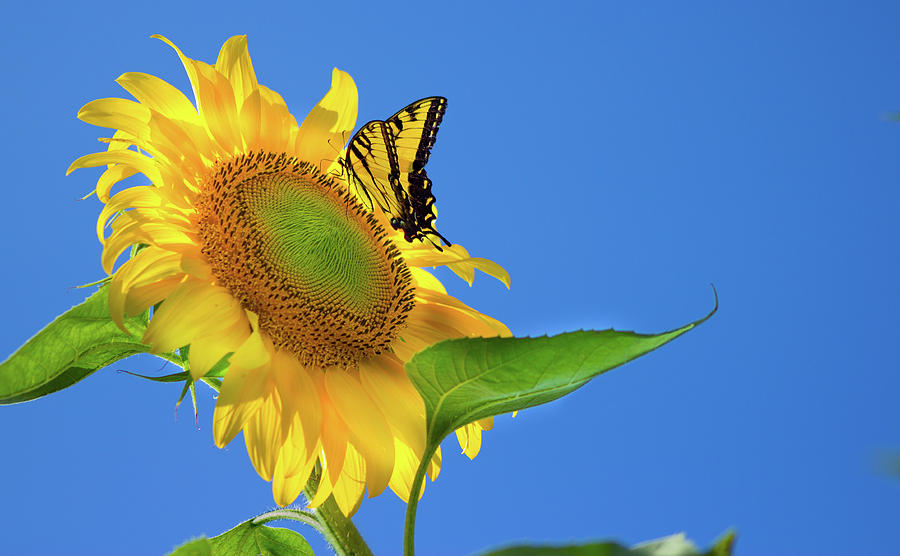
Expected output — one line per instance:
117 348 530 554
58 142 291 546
296 68 359 168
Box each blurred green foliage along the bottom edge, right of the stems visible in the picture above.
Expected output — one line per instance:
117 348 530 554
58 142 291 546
483 533 734 556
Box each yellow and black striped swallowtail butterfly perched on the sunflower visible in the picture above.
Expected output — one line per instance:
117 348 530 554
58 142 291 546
340 97 452 250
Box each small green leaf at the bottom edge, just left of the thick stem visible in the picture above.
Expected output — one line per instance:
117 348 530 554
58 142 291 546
207 519 313 556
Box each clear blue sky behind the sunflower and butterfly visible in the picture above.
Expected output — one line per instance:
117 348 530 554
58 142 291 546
0 2 900 555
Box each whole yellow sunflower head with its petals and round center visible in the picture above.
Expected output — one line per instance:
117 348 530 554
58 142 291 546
68 36 510 515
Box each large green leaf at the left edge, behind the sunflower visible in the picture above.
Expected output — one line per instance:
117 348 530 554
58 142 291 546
0 287 150 404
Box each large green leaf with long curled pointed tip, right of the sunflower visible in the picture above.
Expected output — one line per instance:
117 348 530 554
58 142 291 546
406 294 718 454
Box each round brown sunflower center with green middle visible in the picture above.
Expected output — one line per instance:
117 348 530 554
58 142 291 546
197 153 413 367
